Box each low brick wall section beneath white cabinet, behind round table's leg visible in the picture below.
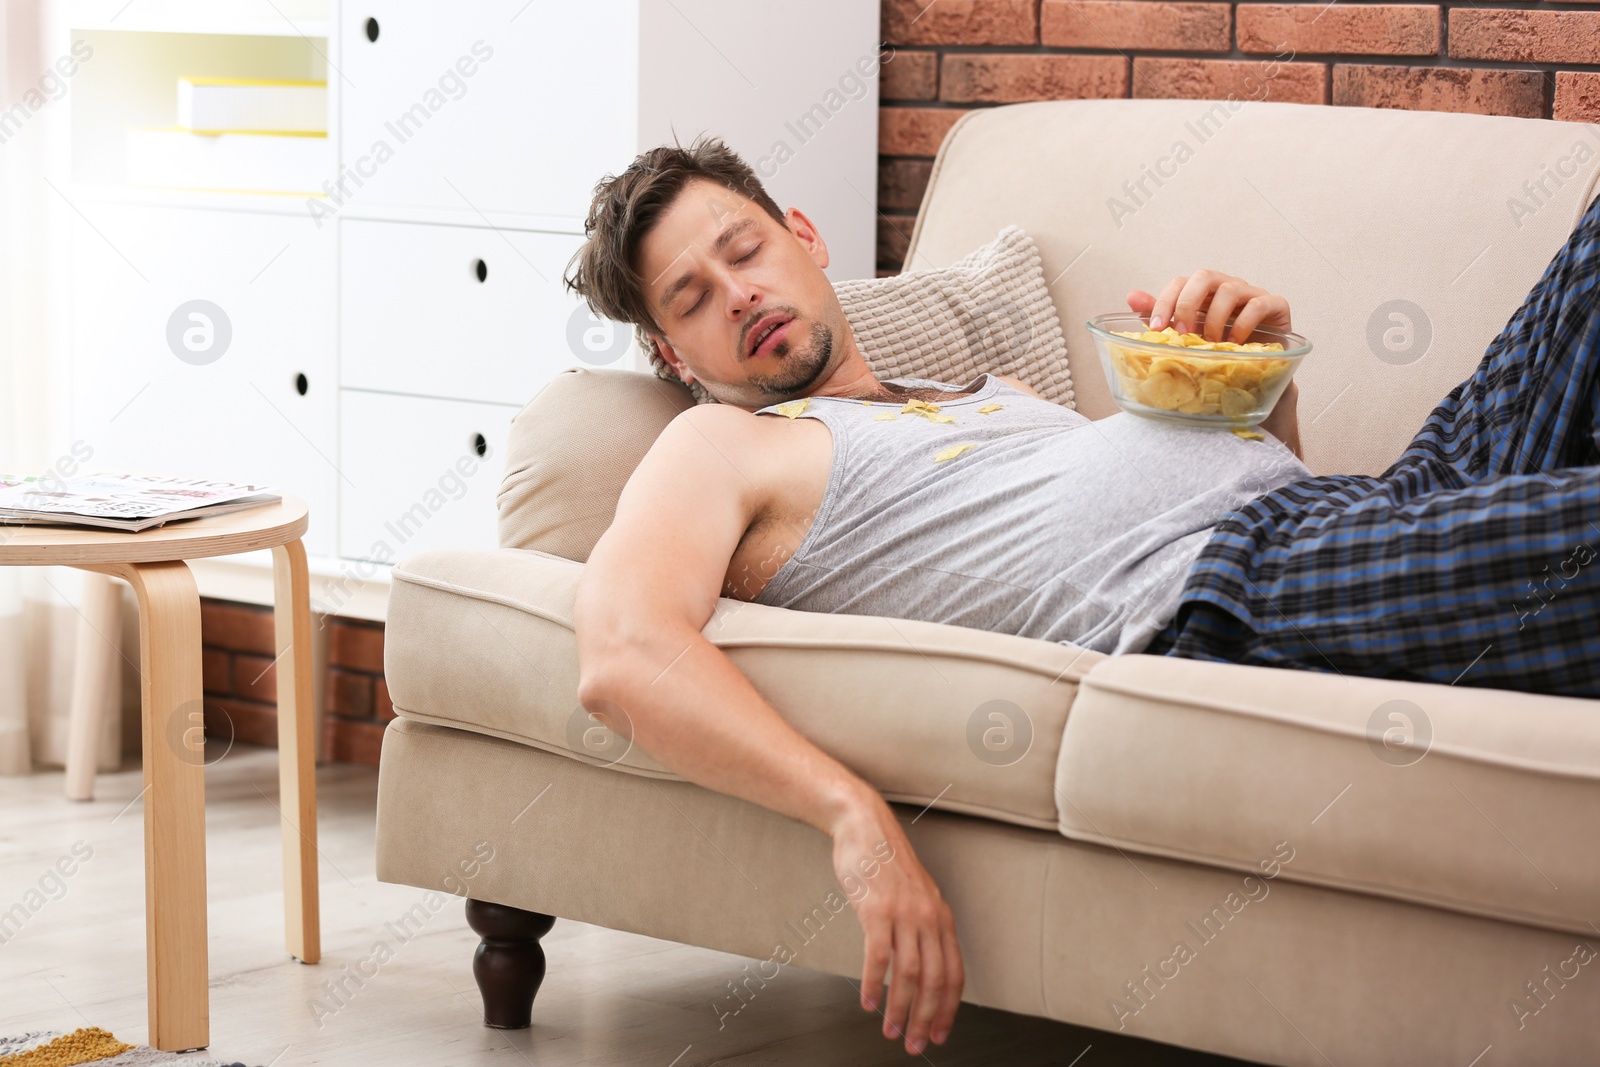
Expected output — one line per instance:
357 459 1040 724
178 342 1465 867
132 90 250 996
200 600 395 766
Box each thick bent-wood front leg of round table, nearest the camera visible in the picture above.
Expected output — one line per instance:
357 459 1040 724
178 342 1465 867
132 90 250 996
94 561 211 1053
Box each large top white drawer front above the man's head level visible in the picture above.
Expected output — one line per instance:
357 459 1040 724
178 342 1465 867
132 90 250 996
339 0 638 219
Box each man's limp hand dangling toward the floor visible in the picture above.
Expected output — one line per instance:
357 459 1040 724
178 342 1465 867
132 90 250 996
832 793 966 1056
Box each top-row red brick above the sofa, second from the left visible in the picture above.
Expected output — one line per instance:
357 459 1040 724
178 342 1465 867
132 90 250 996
1038 0 1234 51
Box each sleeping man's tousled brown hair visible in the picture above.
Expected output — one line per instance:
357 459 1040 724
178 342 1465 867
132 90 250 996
565 134 784 342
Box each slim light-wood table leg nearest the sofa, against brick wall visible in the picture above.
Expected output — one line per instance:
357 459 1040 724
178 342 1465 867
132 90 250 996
272 541 322 963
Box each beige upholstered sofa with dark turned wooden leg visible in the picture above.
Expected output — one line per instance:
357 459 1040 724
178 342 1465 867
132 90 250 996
378 101 1600 1067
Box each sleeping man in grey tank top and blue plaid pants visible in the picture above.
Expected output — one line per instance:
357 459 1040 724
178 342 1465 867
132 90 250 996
568 141 1600 1054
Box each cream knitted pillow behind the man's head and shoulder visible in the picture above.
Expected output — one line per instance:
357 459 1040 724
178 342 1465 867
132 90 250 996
638 226 1075 408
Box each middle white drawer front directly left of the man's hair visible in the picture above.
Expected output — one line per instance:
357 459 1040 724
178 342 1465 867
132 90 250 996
339 219 630 405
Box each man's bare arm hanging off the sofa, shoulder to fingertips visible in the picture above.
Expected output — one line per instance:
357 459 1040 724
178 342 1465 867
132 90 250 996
576 406 963 1053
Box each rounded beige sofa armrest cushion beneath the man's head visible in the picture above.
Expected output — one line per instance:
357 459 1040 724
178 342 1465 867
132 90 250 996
496 366 694 563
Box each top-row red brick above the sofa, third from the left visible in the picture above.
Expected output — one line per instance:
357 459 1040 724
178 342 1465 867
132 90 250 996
1235 3 1438 56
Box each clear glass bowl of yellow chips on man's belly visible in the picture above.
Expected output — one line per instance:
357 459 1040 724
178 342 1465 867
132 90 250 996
1083 312 1310 426
